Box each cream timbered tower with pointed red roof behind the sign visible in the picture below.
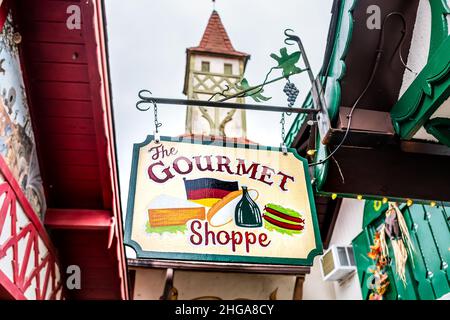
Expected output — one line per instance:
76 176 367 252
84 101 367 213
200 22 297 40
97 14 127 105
183 11 250 139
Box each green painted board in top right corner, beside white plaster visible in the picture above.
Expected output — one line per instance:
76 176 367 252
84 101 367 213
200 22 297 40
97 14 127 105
428 0 450 57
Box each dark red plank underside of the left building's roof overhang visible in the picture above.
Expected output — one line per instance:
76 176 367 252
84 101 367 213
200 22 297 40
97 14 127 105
18 0 107 209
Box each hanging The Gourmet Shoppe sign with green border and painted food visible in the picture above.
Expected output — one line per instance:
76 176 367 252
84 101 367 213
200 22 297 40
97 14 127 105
125 136 322 266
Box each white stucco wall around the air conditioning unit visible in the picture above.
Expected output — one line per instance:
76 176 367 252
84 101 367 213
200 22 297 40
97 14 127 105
303 199 364 300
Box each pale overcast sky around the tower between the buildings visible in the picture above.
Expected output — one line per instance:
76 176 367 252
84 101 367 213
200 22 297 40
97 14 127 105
106 0 332 212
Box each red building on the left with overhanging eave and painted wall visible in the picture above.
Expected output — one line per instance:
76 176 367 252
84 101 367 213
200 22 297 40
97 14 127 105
0 0 128 300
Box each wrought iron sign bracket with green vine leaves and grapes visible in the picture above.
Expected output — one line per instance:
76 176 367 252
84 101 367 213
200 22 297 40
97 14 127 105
136 29 331 144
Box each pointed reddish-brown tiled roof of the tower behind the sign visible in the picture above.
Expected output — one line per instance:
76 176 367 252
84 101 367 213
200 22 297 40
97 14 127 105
188 10 249 57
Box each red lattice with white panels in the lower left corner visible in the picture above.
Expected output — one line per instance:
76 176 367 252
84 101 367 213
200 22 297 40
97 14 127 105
0 157 62 300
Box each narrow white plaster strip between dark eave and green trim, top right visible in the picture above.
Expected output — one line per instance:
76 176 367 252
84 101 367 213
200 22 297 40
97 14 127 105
399 0 431 98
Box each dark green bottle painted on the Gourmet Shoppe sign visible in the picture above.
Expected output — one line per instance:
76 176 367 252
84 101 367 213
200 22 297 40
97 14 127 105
234 186 262 228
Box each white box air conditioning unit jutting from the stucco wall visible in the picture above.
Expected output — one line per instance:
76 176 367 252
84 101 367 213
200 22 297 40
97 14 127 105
320 245 356 281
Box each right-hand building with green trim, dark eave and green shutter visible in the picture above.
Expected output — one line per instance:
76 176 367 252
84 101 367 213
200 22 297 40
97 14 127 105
287 0 450 300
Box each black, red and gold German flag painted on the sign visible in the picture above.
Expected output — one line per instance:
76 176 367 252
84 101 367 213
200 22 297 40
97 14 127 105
184 178 239 207
